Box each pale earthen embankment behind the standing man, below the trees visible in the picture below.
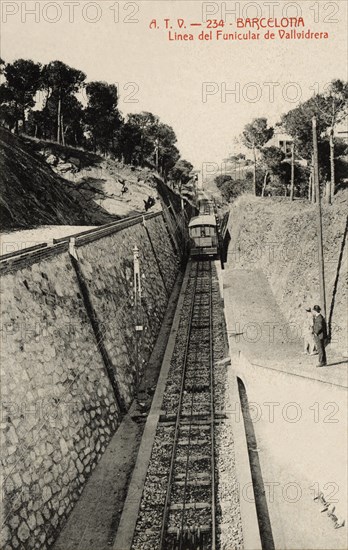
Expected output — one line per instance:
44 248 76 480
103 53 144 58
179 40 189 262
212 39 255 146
228 192 348 352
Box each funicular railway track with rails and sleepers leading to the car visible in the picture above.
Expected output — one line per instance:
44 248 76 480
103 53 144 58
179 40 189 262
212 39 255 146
132 261 217 550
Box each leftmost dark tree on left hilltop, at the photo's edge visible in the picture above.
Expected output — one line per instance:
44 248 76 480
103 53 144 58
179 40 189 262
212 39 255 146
0 59 41 134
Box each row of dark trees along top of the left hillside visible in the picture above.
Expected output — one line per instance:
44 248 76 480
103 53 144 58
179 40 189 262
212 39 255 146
0 59 193 184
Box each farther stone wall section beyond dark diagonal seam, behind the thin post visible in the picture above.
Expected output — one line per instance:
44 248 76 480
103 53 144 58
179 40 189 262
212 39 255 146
77 217 178 412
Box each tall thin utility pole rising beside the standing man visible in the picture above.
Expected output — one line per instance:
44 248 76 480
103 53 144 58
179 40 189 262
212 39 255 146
312 116 326 318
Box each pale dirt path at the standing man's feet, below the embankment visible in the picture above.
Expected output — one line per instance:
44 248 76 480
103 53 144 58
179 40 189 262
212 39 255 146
223 267 347 387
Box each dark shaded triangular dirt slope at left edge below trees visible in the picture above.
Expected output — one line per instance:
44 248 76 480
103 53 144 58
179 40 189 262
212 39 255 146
0 128 117 229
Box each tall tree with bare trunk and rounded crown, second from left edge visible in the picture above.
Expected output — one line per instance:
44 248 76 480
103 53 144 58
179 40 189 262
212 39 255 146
42 61 86 145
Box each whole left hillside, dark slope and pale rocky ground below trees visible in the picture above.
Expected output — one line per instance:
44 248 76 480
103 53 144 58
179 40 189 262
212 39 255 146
0 128 182 230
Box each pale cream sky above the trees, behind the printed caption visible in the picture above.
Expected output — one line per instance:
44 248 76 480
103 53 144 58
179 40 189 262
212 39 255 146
0 0 348 170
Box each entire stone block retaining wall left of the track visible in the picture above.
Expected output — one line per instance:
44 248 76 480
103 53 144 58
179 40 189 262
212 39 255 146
0 215 181 550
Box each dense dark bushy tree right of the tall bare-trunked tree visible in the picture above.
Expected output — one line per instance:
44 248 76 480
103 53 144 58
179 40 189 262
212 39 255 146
85 82 122 154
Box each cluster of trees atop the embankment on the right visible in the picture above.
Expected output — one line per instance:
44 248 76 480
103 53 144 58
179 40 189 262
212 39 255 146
219 79 348 203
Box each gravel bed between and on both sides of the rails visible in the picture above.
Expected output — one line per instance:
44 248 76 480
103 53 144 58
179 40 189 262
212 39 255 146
132 264 243 550
